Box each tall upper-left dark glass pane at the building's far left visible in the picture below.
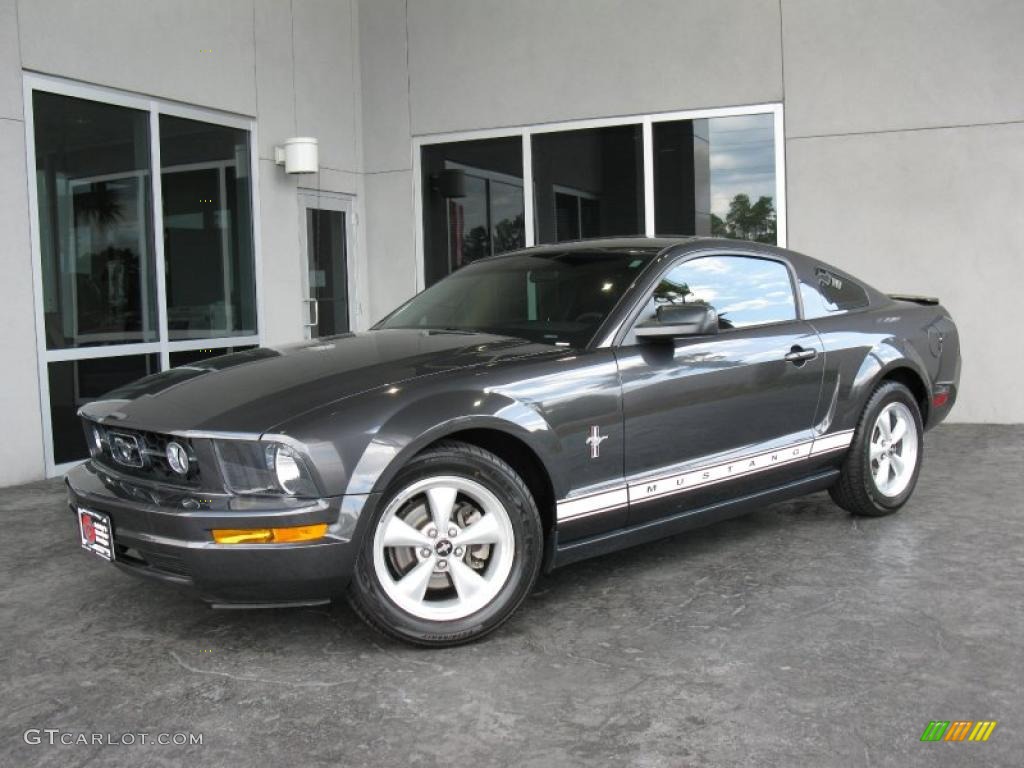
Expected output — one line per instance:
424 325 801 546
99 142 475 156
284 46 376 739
33 91 158 349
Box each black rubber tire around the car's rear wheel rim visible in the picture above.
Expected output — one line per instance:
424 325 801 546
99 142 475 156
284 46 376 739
828 381 925 517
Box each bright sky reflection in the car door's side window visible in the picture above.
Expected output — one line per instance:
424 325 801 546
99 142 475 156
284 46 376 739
671 256 796 328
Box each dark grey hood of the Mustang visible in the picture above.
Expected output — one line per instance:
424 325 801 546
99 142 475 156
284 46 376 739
80 329 564 433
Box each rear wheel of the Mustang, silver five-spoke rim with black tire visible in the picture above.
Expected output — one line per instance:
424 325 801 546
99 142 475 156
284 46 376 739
829 381 924 516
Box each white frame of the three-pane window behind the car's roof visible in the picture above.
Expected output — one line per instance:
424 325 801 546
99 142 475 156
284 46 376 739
412 101 786 290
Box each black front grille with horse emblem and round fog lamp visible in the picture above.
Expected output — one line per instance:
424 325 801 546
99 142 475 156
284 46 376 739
85 422 202 487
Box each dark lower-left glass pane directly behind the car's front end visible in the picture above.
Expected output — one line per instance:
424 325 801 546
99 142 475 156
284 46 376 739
47 354 159 464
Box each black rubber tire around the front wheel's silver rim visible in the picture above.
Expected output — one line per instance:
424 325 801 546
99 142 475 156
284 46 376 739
347 440 544 647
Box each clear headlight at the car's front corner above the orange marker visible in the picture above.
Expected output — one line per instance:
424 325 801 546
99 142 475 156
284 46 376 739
214 440 319 497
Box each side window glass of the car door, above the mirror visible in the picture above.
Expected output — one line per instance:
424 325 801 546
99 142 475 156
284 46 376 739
637 256 797 330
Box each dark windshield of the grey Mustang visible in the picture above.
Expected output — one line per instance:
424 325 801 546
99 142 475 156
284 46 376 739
376 249 656 347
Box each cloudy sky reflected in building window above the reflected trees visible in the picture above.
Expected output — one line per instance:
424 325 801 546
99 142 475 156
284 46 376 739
708 115 777 219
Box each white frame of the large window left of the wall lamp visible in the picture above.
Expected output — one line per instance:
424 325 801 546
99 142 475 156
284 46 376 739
22 72 264 477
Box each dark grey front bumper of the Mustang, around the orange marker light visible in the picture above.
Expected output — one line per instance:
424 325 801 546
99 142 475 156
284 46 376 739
66 462 376 606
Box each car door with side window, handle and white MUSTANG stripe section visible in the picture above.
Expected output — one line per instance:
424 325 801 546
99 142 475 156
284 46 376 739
616 254 824 525
